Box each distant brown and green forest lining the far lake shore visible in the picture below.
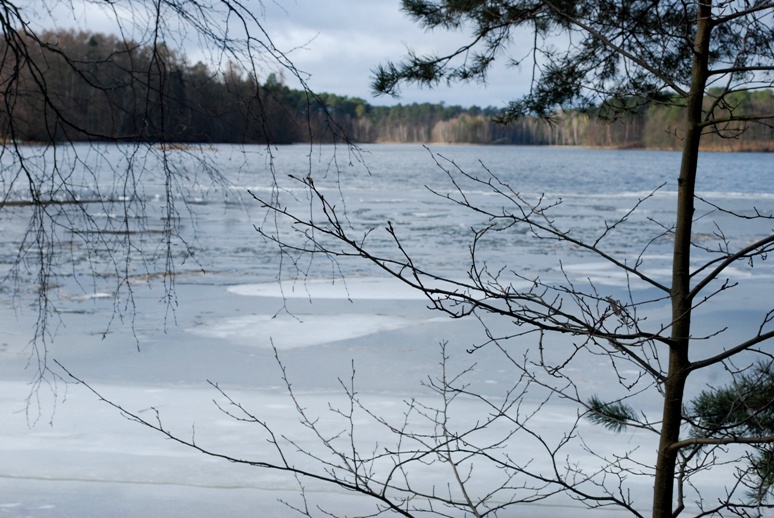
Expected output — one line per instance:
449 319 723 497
0 31 774 151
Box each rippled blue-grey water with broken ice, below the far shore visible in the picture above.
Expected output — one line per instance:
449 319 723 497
0 144 774 284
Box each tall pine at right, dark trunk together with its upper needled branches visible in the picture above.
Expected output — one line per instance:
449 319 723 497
373 0 774 517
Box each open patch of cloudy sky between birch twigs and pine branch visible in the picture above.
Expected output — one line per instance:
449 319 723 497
258 0 529 106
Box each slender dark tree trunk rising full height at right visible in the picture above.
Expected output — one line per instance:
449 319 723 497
653 5 712 518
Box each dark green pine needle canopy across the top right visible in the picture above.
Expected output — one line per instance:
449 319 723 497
373 0 774 120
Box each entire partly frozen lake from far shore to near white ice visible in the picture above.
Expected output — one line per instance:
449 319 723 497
0 145 774 517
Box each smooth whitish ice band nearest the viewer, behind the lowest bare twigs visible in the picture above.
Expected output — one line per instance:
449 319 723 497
0 381 660 518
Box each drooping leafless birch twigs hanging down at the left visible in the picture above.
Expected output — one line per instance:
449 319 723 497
0 0 342 406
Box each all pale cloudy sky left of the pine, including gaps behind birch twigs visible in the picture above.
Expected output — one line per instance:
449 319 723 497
36 0 530 107
